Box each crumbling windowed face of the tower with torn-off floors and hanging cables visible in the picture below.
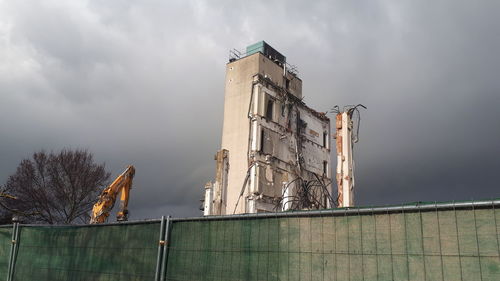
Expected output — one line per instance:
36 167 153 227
246 75 333 212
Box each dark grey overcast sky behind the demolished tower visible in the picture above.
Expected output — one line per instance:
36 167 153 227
0 0 500 219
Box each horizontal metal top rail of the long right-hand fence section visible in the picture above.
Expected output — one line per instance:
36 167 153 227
171 199 500 222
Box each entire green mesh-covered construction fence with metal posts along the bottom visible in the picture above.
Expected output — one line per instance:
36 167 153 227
0 200 500 281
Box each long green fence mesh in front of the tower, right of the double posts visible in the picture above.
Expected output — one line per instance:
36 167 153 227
167 209 500 281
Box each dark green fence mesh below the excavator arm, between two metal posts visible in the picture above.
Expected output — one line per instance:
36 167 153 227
14 223 160 281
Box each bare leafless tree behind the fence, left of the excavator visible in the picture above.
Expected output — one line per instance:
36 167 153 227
0 150 110 224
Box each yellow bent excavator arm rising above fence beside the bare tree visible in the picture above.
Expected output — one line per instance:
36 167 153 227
90 165 135 224
